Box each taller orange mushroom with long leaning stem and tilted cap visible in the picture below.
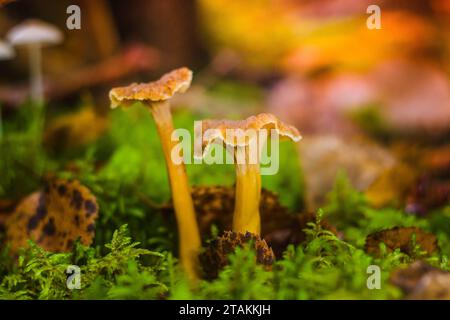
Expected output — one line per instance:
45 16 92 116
109 68 201 280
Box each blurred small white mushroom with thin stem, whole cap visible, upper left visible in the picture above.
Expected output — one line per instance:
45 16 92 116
7 20 63 103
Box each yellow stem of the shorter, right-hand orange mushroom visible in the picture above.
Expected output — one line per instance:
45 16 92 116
233 147 261 235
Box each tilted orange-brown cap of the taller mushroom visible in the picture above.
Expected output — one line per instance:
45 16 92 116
109 67 192 108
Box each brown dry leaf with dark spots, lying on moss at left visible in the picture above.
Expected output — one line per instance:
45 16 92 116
6 179 98 253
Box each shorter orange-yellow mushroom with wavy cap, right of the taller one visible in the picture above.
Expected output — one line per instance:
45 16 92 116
196 113 301 235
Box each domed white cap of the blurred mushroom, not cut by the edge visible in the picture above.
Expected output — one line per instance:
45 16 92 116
7 19 63 45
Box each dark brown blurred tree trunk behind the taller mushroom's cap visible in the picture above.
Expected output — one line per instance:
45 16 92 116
112 0 207 70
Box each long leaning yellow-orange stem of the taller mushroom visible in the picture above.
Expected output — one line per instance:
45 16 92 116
150 101 201 279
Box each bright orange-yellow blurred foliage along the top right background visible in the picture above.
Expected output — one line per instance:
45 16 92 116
199 0 436 74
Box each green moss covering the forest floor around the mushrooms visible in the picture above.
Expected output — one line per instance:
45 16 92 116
0 101 450 299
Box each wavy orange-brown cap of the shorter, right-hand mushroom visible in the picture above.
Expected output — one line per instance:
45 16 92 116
194 113 302 158
